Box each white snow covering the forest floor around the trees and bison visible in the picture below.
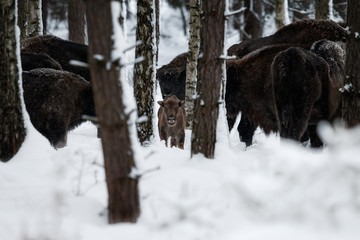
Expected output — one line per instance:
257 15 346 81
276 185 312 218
0 2 360 240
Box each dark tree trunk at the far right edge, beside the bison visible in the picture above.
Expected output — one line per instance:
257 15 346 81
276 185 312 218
342 0 360 127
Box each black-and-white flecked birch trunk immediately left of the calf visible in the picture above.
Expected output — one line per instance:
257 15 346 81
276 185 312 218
134 0 155 146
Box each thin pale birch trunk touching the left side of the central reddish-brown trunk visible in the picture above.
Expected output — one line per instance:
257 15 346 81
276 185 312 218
185 0 201 129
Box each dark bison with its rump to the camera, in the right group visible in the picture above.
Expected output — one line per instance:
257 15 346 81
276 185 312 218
272 47 329 147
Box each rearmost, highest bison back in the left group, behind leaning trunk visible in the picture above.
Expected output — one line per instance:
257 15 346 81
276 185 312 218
21 35 90 81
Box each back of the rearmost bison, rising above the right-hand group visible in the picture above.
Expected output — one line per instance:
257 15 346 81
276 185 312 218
228 19 347 58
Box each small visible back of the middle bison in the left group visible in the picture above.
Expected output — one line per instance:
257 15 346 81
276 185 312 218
21 52 62 71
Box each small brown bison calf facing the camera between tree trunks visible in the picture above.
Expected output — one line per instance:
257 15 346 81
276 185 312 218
158 96 186 149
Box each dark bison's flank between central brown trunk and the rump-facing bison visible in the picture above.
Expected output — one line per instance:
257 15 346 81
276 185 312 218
225 44 300 146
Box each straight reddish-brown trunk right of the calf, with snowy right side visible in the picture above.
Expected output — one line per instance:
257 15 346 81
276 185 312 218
191 0 225 158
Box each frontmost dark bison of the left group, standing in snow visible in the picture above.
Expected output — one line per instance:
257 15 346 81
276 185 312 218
22 68 95 148
